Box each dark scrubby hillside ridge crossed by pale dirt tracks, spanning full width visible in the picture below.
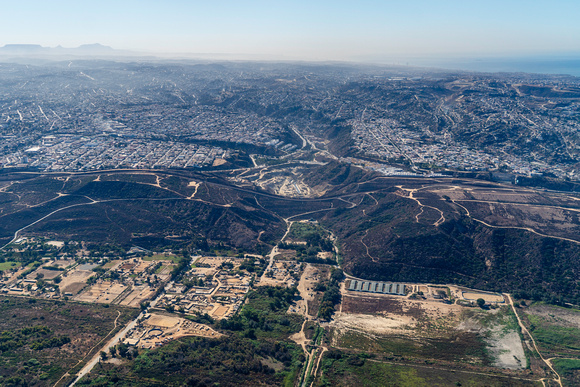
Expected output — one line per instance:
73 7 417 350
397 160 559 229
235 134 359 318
0 162 580 304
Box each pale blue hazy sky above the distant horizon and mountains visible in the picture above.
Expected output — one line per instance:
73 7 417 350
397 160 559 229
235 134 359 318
0 0 580 60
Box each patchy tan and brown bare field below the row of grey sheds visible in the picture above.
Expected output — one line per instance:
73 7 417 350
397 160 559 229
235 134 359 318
328 289 526 370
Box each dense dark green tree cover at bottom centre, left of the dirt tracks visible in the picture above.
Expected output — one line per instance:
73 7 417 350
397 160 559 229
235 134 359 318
81 287 304 387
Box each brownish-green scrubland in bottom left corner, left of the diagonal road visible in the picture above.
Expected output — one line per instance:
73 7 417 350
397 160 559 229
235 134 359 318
0 297 138 385
